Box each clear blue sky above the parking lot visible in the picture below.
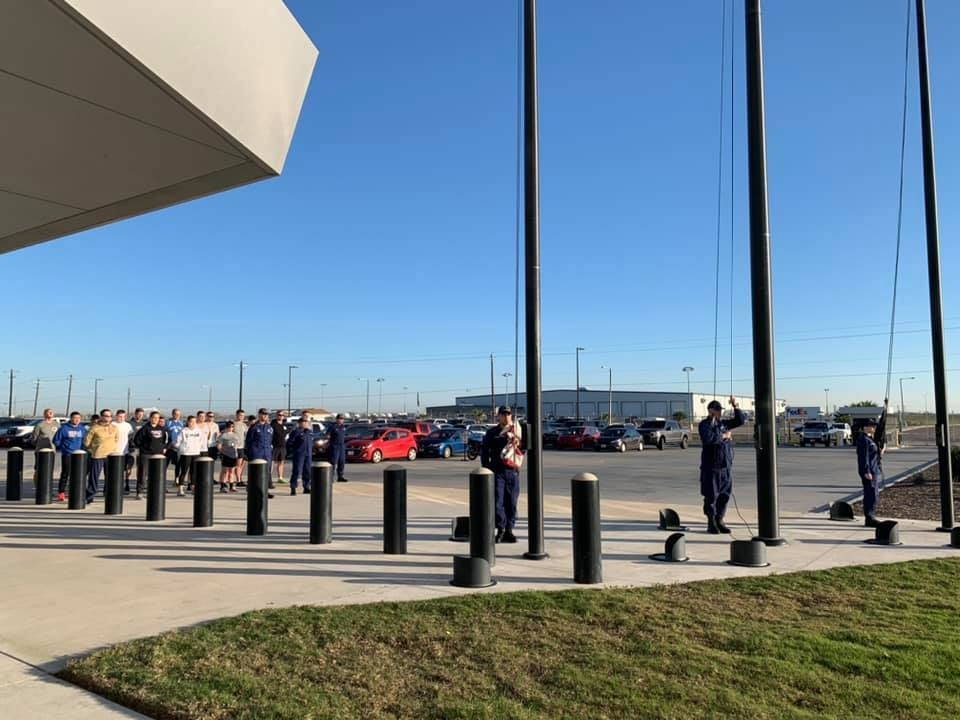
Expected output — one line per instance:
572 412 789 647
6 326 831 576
0 0 960 411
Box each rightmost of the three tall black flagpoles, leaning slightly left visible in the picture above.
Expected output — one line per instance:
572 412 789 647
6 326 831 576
917 0 954 532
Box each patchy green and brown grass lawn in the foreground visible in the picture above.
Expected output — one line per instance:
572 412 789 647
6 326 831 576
61 559 960 720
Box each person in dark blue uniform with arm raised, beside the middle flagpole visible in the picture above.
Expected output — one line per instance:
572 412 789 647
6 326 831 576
699 397 746 535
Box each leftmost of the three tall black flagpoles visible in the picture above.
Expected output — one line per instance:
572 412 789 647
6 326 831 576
522 0 549 560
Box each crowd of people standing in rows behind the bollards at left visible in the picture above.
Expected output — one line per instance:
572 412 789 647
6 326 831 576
32 408 346 503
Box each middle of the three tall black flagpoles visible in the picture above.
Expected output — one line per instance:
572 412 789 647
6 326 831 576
744 0 786 545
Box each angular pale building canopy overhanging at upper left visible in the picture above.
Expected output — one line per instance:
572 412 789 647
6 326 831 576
0 0 317 252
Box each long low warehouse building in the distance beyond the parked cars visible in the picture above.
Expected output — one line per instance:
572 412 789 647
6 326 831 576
427 388 787 421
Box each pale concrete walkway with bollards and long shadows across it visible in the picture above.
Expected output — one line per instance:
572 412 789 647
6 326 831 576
0 482 960 720
